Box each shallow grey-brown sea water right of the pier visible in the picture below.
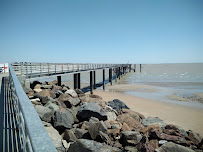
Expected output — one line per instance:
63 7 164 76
116 63 203 108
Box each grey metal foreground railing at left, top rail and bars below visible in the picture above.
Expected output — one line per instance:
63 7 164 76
9 65 56 152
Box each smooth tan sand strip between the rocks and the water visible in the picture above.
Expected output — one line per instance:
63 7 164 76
94 90 203 136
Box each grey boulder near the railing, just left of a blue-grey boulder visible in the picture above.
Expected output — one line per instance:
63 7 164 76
35 105 54 122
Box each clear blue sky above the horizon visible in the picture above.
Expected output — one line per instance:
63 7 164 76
0 0 203 64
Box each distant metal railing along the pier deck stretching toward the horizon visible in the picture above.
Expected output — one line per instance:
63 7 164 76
11 62 131 78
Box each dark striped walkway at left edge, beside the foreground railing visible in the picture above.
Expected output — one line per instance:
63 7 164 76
0 74 21 152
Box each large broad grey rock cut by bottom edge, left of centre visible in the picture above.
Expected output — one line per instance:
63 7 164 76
68 139 121 152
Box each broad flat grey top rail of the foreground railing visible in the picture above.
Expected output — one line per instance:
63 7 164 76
9 64 56 152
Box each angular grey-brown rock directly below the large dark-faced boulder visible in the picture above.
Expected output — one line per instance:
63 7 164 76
88 121 108 140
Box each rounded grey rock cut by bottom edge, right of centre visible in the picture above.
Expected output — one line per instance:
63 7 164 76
155 142 194 152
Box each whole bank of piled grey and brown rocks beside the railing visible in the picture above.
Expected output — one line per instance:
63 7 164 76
24 81 203 152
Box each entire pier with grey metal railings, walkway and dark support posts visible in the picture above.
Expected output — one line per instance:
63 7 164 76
0 62 135 152
